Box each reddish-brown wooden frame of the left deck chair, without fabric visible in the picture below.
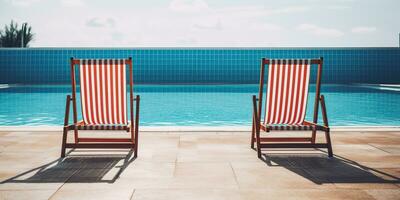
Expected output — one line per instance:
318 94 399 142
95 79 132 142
61 57 140 158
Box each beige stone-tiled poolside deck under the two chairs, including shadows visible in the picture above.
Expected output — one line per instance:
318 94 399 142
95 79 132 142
0 132 400 200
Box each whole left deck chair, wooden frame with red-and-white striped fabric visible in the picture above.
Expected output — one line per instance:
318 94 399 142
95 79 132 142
61 58 140 158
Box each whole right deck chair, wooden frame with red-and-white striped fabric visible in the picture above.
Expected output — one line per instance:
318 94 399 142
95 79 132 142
251 57 333 158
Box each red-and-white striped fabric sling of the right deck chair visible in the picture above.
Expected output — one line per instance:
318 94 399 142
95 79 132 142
264 60 311 125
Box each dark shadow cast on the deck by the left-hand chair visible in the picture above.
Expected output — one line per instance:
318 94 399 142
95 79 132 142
0 150 135 184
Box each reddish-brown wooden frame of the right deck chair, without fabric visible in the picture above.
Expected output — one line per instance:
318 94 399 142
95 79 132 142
251 57 333 158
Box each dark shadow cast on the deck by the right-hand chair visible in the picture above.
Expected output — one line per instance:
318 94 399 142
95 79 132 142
262 153 400 184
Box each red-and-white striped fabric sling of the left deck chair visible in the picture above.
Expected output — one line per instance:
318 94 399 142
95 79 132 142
79 59 128 125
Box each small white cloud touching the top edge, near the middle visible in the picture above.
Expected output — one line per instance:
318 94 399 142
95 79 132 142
169 0 209 12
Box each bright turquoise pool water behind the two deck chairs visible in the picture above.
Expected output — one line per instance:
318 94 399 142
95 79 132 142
0 84 400 126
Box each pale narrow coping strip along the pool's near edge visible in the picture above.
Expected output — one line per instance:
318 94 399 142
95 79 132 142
0 126 400 132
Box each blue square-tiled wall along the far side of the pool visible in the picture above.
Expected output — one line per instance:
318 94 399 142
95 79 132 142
0 47 400 84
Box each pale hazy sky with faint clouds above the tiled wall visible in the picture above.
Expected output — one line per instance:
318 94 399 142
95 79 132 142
0 0 400 47
